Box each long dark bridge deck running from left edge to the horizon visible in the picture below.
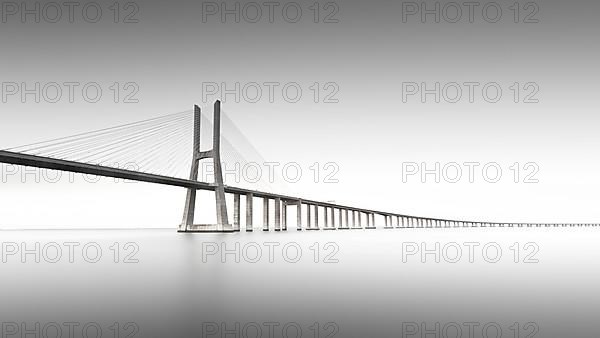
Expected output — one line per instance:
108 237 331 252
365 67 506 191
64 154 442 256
0 150 598 227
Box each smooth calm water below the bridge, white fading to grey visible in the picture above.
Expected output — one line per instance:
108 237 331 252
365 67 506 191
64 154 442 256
0 228 600 337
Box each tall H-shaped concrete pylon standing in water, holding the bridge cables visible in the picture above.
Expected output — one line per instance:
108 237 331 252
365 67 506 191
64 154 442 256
178 100 235 232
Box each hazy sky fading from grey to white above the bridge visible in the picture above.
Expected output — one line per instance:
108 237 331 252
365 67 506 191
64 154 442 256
0 1 600 226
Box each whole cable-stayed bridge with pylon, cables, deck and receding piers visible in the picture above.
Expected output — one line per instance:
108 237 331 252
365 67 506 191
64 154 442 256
0 101 598 232
